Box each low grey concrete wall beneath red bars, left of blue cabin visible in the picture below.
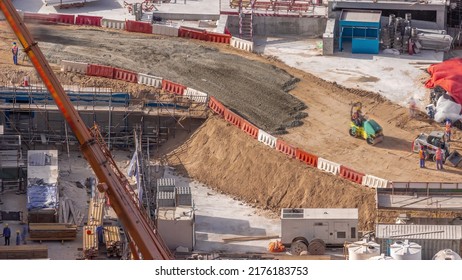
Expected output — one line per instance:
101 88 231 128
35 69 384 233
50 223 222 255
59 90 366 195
228 16 327 37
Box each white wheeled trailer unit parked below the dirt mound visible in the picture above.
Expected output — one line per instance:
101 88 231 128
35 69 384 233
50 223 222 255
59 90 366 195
281 208 358 255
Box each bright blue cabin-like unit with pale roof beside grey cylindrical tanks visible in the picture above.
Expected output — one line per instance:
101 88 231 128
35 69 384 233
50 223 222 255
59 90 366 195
339 10 382 54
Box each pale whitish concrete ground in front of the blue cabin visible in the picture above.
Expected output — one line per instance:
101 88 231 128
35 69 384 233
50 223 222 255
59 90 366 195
255 36 444 108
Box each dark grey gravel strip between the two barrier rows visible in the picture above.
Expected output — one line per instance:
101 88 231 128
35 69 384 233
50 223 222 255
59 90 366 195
31 26 306 133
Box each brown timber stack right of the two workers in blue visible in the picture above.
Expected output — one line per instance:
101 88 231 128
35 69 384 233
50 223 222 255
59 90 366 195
29 223 77 241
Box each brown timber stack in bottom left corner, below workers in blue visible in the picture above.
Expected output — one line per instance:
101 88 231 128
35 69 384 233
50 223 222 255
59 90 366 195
0 245 48 260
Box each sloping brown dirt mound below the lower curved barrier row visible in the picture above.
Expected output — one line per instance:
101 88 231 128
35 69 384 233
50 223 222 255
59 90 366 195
167 117 375 230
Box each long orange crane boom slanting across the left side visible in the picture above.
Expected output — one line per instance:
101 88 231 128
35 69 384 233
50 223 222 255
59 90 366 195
0 0 173 260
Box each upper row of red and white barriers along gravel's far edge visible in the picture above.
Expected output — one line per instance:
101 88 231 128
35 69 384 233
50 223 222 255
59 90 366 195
22 13 254 52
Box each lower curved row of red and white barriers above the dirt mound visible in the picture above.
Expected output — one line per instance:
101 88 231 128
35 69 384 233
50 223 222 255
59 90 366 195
61 60 400 188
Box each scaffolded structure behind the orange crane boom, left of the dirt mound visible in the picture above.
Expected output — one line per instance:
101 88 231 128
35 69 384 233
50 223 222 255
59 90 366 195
0 85 206 150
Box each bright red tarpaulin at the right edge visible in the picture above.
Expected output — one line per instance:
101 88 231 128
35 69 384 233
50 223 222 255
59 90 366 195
425 58 462 104
